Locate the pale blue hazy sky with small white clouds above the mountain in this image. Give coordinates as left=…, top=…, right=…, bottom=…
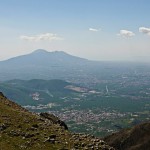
left=0, top=0, right=150, bottom=61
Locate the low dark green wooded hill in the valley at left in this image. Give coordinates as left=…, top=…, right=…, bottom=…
left=0, top=79, right=74, bottom=105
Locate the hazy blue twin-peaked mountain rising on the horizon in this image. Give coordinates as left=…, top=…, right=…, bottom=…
left=0, top=49, right=88, bottom=66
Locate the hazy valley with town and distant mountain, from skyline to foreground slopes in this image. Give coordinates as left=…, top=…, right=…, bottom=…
left=0, top=49, right=150, bottom=137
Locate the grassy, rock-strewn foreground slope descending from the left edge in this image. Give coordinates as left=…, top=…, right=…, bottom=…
left=0, top=92, right=113, bottom=150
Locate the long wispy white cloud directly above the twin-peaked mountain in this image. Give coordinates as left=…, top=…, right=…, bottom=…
left=20, top=33, right=63, bottom=42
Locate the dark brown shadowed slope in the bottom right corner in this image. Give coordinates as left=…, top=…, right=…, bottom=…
left=104, top=122, right=150, bottom=150
